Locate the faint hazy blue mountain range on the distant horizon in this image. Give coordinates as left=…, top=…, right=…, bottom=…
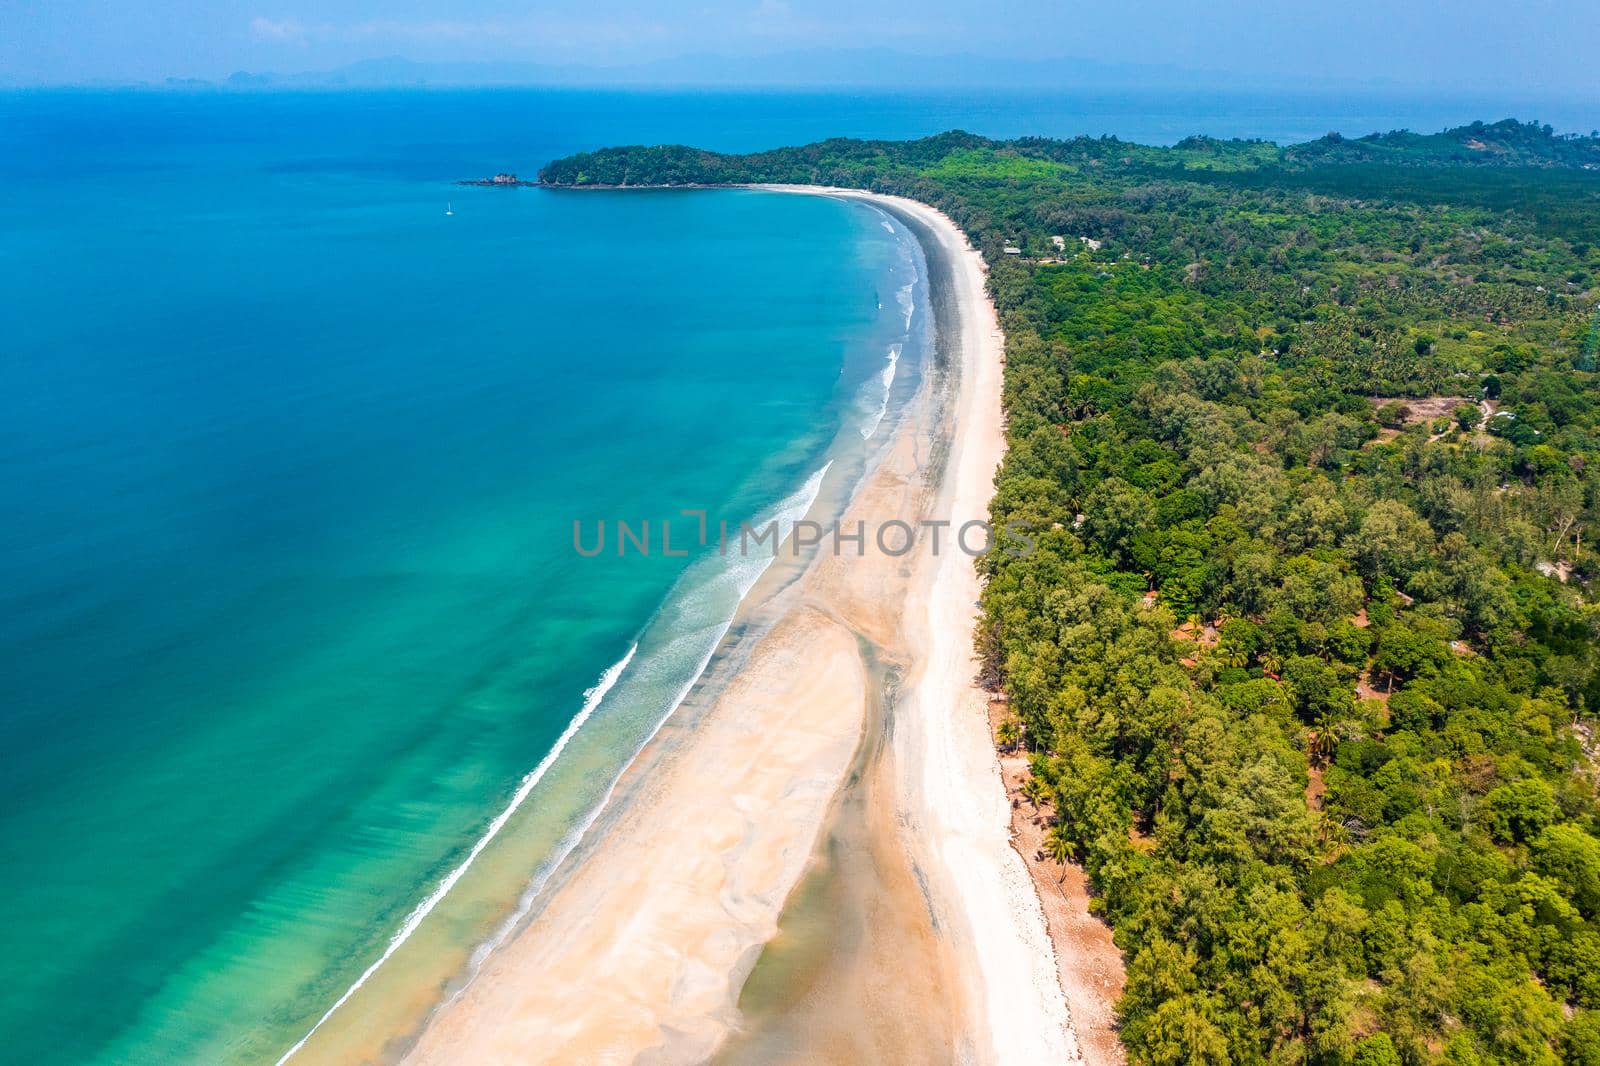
left=206, top=48, right=1324, bottom=90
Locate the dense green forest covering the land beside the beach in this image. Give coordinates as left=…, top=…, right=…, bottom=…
left=542, top=122, right=1600, bottom=1066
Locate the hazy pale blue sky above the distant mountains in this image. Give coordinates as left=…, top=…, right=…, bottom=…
left=0, top=0, right=1600, bottom=98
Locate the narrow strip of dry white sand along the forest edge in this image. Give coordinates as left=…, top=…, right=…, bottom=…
left=876, top=186, right=1082, bottom=1063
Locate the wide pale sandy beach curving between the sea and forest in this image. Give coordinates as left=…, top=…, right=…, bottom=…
left=392, top=189, right=1078, bottom=1063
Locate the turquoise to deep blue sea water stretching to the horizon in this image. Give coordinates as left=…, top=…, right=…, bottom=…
left=0, top=91, right=1578, bottom=1063
